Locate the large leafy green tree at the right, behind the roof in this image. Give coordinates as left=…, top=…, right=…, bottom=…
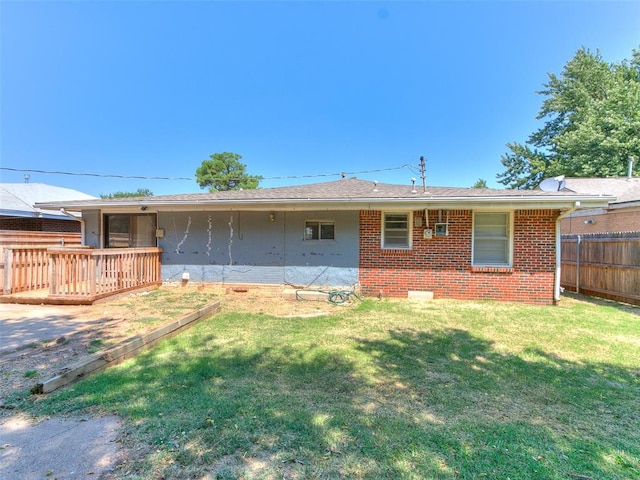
left=497, top=48, right=640, bottom=188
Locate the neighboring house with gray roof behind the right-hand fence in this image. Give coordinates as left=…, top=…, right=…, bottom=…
left=562, top=177, right=640, bottom=235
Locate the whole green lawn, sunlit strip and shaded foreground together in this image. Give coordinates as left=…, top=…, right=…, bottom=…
left=17, top=297, right=640, bottom=479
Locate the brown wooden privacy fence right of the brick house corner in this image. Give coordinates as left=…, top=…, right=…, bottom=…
left=560, top=232, right=640, bottom=305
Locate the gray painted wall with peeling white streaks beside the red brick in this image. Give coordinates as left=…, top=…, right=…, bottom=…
left=158, top=211, right=359, bottom=286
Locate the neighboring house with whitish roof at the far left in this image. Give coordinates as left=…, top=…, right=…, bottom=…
left=0, top=183, right=95, bottom=233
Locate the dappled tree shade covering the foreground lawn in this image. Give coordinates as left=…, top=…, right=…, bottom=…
left=27, top=320, right=640, bottom=479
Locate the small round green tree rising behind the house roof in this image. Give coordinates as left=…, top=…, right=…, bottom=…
left=196, top=152, right=262, bottom=192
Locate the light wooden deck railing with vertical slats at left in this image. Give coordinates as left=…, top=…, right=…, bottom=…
left=4, top=247, right=162, bottom=303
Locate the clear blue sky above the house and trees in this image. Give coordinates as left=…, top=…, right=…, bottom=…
left=0, top=0, right=640, bottom=196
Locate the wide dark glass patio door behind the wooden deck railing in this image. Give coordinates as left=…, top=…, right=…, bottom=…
left=104, top=214, right=157, bottom=248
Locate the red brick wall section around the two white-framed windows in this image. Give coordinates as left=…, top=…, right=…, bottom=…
left=359, top=210, right=560, bottom=304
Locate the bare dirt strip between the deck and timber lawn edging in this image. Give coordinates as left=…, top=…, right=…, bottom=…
left=0, top=285, right=336, bottom=404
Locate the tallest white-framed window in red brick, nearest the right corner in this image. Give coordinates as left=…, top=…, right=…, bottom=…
left=472, top=212, right=511, bottom=266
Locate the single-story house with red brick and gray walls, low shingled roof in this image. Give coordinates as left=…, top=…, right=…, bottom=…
left=33, top=179, right=614, bottom=304
